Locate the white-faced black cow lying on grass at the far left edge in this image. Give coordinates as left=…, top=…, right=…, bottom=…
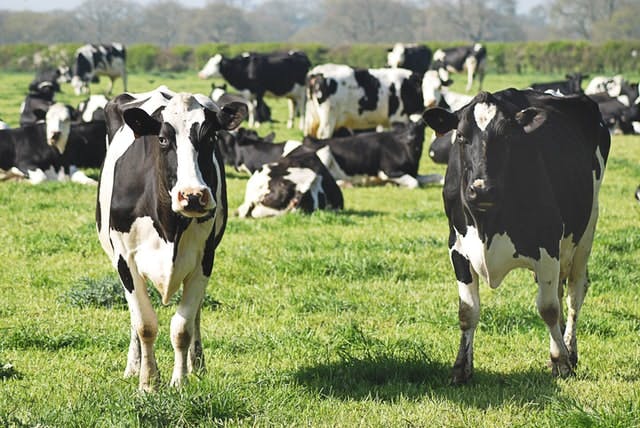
left=0, top=103, right=95, bottom=184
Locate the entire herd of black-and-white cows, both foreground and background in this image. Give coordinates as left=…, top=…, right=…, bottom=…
left=0, top=40, right=640, bottom=390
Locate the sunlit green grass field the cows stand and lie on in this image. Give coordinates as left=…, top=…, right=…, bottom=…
left=0, top=73, right=640, bottom=427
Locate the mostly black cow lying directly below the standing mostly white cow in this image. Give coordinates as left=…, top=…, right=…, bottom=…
left=303, top=113, right=442, bottom=189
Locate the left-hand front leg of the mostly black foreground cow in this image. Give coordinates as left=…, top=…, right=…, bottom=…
left=449, top=249, right=480, bottom=385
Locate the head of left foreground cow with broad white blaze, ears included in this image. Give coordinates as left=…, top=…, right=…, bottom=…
left=123, top=93, right=247, bottom=217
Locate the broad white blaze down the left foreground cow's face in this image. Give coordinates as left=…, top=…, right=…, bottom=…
left=162, top=93, right=216, bottom=216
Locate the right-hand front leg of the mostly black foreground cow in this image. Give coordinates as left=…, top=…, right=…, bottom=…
left=535, top=256, right=573, bottom=377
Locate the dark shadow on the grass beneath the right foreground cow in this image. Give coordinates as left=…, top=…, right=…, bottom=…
left=294, top=357, right=559, bottom=409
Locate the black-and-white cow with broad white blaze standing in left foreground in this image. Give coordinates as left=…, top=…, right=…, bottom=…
left=96, top=87, right=247, bottom=390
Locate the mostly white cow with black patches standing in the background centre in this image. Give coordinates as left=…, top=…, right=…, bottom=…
left=304, top=64, right=424, bottom=138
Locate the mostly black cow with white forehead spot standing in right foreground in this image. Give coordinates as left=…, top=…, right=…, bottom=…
left=424, top=89, right=610, bottom=384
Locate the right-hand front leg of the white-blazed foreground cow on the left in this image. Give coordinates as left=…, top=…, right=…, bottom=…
left=171, top=273, right=208, bottom=386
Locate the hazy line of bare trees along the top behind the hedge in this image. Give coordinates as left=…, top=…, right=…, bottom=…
left=0, top=0, right=640, bottom=48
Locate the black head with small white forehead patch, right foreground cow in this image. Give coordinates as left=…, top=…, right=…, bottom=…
left=424, top=92, right=547, bottom=212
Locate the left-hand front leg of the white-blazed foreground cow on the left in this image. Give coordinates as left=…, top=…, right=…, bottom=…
left=118, top=270, right=160, bottom=391
